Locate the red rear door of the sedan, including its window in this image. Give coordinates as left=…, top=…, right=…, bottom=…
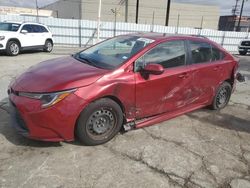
left=189, top=40, right=226, bottom=104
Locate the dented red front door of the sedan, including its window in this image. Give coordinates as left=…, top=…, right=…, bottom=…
left=135, top=40, right=192, bottom=119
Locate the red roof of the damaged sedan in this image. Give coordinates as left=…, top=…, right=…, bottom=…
left=125, top=32, right=207, bottom=41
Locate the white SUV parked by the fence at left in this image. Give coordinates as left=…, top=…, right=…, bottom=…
left=0, top=21, right=53, bottom=56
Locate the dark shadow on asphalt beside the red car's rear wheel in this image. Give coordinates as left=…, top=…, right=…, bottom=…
left=186, top=106, right=250, bottom=133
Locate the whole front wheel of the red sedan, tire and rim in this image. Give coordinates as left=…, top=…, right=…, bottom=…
left=76, top=98, right=123, bottom=146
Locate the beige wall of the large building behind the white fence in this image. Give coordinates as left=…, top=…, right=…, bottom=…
left=45, top=0, right=219, bottom=29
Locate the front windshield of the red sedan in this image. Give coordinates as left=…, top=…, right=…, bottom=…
left=75, top=36, right=154, bottom=69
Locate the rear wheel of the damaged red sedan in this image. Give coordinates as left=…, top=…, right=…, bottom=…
left=211, top=82, right=232, bottom=110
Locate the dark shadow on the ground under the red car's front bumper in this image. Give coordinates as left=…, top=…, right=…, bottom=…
left=0, top=98, right=61, bottom=148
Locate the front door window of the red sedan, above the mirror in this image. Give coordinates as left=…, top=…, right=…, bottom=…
left=135, top=40, right=186, bottom=71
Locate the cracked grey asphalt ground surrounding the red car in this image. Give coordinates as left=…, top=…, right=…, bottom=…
left=0, top=48, right=250, bottom=188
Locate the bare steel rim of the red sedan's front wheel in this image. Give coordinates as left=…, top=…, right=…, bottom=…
left=86, top=108, right=117, bottom=140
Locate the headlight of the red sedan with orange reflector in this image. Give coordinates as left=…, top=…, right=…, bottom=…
left=19, top=89, right=76, bottom=108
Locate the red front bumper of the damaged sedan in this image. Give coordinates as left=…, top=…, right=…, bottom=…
left=9, top=93, right=87, bottom=142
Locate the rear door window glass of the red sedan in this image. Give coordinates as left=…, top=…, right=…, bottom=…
left=189, top=41, right=212, bottom=64
